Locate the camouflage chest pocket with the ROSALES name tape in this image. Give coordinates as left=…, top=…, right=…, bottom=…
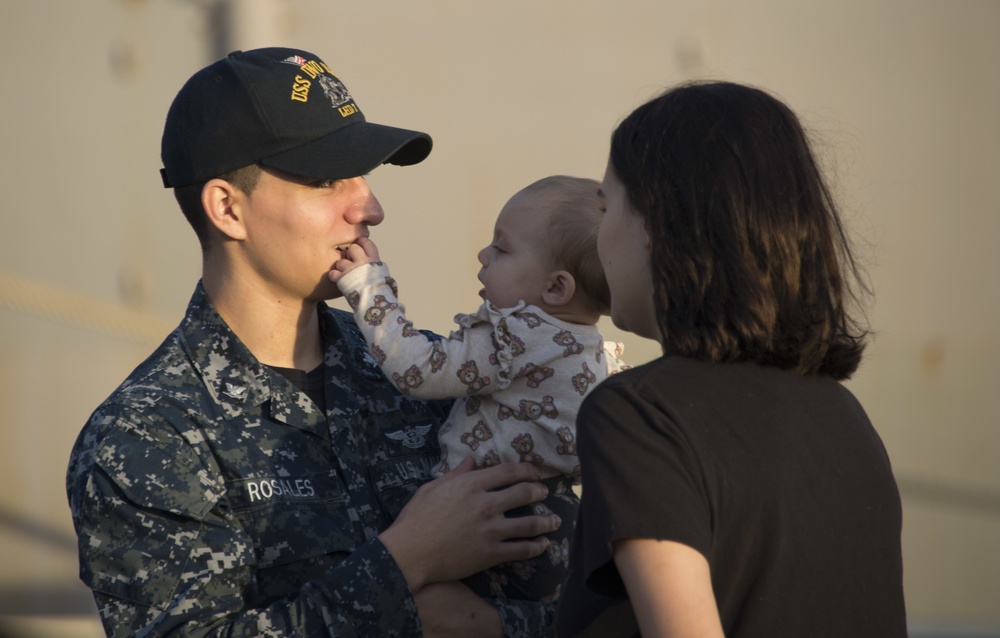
left=228, top=474, right=358, bottom=569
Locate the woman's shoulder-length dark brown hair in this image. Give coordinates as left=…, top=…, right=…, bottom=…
left=610, top=82, right=868, bottom=379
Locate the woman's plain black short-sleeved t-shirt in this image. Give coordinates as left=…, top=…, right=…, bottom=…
left=557, top=357, right=906, bottom=638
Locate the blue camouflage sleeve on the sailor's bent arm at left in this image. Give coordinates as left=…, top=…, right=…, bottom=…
left=67, top=411, right=421, bottom=637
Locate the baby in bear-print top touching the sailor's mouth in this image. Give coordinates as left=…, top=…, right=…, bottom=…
left=330, top=176, right=626, bottom=602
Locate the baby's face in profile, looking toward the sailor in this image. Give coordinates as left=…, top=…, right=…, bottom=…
left=479, top=193, right=553, bottom=308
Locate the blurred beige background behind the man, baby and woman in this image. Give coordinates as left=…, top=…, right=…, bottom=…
left=0, top=0, right=1000, bottom=637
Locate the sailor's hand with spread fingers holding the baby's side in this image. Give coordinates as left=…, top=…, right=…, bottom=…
left=379, top=457, right=561, bottom=592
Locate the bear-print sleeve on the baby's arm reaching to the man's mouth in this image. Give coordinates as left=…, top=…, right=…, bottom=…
left=338, top=262, right=511, bottom=399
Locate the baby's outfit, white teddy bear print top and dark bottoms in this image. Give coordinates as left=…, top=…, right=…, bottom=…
left=339, top=262, right=627, bottom=602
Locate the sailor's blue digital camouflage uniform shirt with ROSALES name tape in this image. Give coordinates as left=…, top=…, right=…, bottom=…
left=67, top=284, right=552, bottom=637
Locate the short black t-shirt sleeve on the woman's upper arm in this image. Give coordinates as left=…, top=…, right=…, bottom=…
left=577, top=375, right=712, bottom=597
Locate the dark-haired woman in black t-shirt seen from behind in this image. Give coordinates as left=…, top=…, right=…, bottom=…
left=557, top=83, right=906, bottom=638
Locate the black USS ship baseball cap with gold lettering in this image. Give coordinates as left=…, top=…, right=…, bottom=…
left=160, top=47, right=431, bottom=188
